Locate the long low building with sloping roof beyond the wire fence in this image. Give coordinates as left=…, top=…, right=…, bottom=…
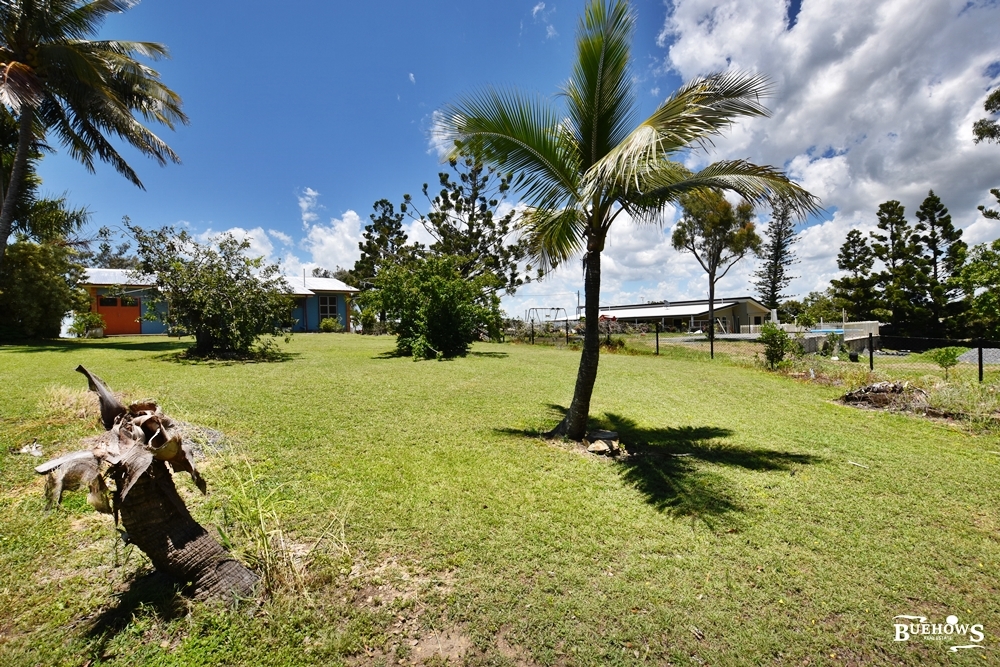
left=600, top=296, right=771, bottom=333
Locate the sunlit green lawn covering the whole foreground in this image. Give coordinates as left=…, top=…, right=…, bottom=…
left=0, top=335, right=1000, bottom=665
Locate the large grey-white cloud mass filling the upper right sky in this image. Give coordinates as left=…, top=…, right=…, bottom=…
left=659, top=0, right=1000, bottom=294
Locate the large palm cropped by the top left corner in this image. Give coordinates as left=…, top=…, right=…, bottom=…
left=0, top=0, right=187, bottom=272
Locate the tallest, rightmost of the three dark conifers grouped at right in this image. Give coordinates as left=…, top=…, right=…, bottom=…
left=916, top=190, right=968, bottom=336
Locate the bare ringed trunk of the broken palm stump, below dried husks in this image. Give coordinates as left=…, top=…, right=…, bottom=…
left=119, top=460, right=257, bottom=600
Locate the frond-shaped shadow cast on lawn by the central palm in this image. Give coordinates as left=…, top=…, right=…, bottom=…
left=598, top=413, right=822, bottom=529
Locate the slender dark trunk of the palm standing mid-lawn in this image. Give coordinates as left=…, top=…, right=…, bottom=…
left=551, top=250, right=601, bottom=440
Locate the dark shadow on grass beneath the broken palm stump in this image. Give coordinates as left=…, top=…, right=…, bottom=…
left=87, top=572, right=187, bottom=648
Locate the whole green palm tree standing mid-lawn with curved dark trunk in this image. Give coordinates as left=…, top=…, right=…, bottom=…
left=442, top=0, right=818, bottom=440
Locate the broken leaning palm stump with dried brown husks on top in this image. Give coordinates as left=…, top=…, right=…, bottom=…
left=35, top=366, right=257, bottom=599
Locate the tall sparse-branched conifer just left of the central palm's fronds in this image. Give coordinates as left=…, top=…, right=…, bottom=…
left=400, top=156, right=531, bottom=294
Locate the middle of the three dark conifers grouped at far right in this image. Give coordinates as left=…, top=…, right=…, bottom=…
left=871, top=200, right=931, bottom=336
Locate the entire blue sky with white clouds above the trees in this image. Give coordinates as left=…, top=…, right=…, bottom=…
left=40, top=0, right=1000, bottom=314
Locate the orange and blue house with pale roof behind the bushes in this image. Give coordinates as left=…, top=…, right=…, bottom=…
left=81, top=269, right=358, bottom=336
